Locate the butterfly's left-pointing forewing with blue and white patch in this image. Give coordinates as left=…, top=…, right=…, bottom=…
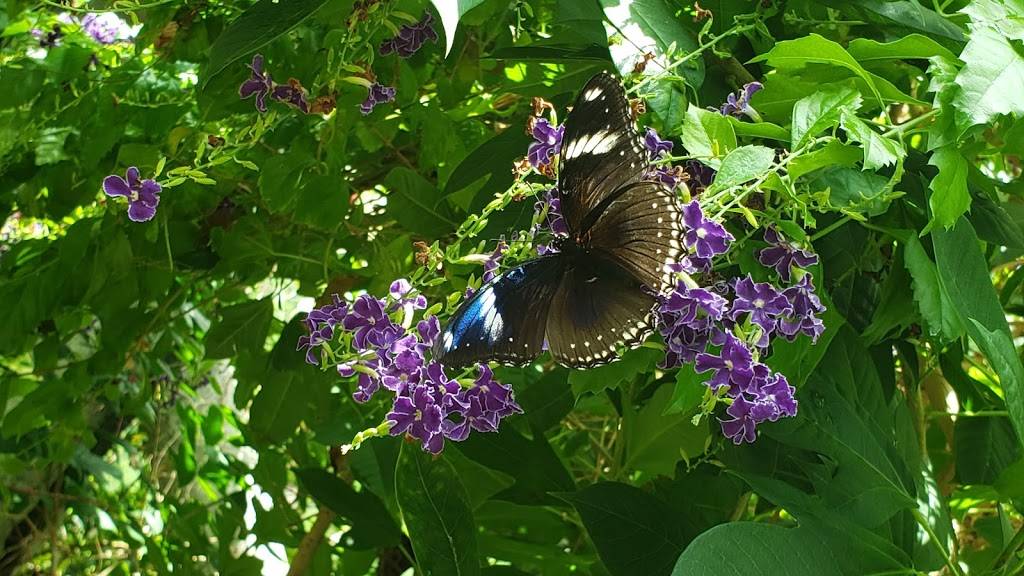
left=433, top=254, right=563, bottom=367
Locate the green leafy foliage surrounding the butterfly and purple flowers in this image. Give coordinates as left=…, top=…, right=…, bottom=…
left=0, top=0, right=1024, bottom=576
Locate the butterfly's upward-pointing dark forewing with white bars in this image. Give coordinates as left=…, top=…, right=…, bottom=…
left=558, top=72, right=647, bottom=232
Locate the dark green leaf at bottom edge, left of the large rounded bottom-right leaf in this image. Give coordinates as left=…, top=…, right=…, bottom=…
left=558, top=482, right=689, bottom=576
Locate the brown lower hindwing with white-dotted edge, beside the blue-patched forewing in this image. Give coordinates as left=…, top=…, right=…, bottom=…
left=547, top=253, right=655, bottom=368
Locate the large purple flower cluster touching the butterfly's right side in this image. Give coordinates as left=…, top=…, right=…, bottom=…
left=657, top=201, right=824, bottom=444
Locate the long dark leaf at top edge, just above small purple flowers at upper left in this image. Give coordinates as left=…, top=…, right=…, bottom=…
left=201, top=0, right=327, bottom=89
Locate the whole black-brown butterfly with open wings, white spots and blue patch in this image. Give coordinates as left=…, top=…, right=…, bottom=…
left=434, top=73, right=682, bottom=368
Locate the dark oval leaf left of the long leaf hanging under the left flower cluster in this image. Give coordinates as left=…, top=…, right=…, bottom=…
left=295, top=468, right=401, bottom=549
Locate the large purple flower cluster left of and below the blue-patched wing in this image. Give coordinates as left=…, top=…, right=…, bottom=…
left=298, top=280, right=522, bottom=453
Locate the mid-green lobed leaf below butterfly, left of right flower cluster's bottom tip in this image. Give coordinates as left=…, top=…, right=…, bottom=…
left=623, top=384, right=711, bottom=477
